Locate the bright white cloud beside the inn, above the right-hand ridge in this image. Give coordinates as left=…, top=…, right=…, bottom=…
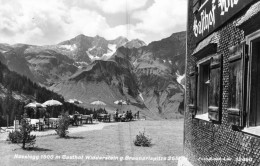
left=132, top=0, right=187, bottom=40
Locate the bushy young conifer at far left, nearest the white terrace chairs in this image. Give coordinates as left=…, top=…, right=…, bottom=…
left=9, top=118, right=36, bottom=149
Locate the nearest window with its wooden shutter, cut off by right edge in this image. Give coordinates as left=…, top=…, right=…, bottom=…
left=227, top=30, right=260, bottom=135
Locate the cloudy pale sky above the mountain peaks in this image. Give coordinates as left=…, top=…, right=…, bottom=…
left=0, top=0, right=187, bottom=45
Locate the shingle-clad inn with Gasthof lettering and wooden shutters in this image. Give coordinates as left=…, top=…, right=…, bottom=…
left=184, top=0, right=260, bottom=166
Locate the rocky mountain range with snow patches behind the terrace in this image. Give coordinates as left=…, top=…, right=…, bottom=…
left=0, top=32, right=186, bottom=119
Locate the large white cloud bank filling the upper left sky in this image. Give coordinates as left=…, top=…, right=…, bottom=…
left=0, top=0, right=109, bottom=45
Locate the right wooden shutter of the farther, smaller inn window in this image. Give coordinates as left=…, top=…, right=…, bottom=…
left=208, top=55, right=223, bottom=122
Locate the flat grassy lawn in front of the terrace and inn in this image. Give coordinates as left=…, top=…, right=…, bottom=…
left=0, top=119, right=183, bottom=166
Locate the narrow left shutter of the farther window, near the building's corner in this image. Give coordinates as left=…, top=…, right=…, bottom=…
left=189, top=67, right=198, bottom=116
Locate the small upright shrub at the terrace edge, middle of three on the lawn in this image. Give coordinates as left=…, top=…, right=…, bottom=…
left=55, top=112, right=70, bottom=138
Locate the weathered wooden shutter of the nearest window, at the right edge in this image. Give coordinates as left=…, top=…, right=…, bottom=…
left=227, top=43, right=247, bottom=130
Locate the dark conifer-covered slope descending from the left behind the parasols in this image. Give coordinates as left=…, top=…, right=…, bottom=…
left=0, top=62, right=92, bottom=126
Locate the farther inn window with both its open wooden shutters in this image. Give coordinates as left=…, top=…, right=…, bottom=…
left=190, top=54, right=222, bottom=122
